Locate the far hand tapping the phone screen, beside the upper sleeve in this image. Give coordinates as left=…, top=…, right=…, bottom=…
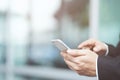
left=78, top=39, right=107, bottom=55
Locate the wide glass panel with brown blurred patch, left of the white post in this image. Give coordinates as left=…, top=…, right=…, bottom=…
left=28, top=0, right=89, bottom=68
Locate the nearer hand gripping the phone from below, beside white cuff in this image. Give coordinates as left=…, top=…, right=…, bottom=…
left=61, top=50, right=98, bottom=76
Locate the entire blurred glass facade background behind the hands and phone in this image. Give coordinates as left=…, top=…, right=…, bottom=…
left=0, top=0, right=120, bottom=80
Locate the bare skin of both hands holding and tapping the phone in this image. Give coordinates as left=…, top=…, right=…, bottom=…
left=61, top=39, right=106, bottom=76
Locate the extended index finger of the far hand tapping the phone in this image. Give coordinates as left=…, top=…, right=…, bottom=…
left=78, top=39, right=95, bottom=49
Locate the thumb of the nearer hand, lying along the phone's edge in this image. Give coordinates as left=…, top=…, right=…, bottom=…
left=67, top=49, right=86, bottom=57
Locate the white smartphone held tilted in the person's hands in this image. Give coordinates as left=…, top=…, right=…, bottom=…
left=52, top=39, right=70, bottom=52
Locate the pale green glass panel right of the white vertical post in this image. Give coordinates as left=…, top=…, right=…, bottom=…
left=99, top=0, right=120, bottom=45
